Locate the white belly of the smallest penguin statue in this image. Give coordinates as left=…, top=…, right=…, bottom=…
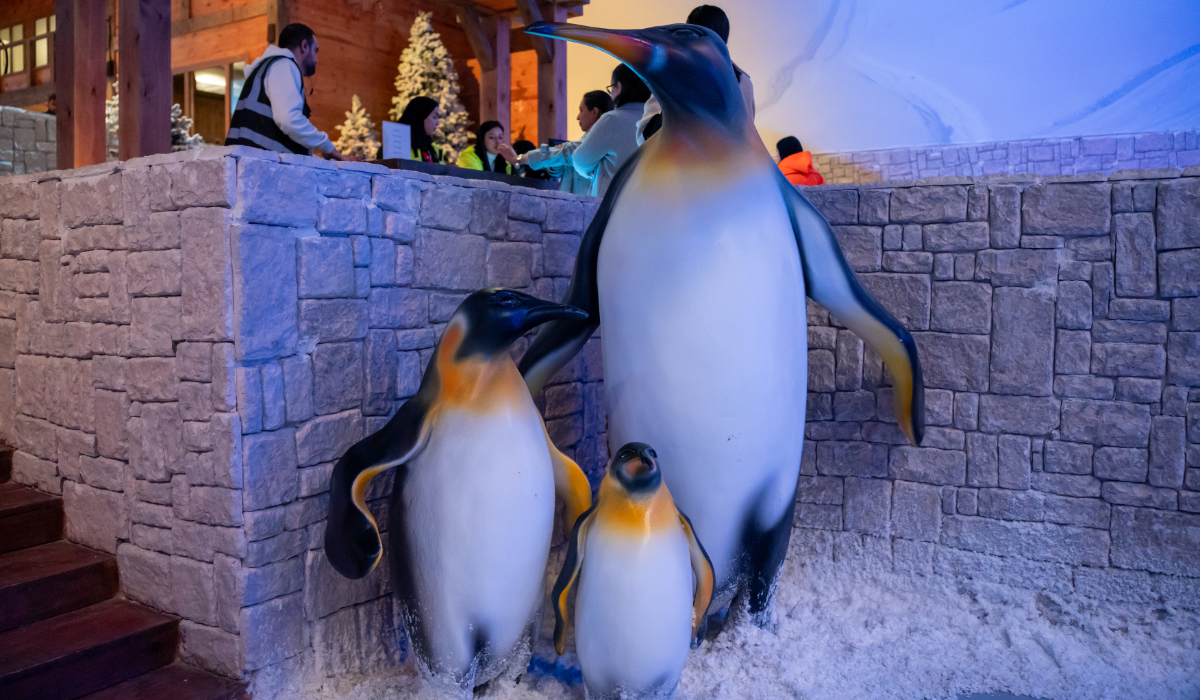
left=575, top=527, right=692, bottom=698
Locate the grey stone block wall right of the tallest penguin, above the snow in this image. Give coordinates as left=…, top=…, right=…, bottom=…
left=797, top=168, right=1200, bottom=608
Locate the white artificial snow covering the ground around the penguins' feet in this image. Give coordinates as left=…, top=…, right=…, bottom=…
left=258, top=539, right=1200, bottom=700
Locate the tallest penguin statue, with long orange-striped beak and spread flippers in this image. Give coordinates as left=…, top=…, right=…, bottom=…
left=521, top=23, right=924, bottom=626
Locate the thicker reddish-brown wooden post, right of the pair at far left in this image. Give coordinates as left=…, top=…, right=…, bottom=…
left=118, top=0, right=172, bottom=161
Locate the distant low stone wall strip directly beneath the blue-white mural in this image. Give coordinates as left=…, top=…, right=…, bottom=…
left=814, top=131, right=1200, bottom=184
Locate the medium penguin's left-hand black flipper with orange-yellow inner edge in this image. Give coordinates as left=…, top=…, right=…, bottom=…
left=325, top=394, right=430, bottom=579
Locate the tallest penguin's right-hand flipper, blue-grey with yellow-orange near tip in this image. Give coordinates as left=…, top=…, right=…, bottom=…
left=775, top=168, right=925, bottom=445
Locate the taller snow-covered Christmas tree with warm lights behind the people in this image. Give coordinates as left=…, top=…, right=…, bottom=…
left=389, top=12, right=473, bottom=163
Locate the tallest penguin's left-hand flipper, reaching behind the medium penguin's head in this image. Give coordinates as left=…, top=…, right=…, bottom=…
left=520, top=150, right=642, bottom=396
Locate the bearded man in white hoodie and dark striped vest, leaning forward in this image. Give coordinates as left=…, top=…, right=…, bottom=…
left=226, top=24, right=359, bottom=161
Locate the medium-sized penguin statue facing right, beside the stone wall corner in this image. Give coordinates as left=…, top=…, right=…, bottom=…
left=325, top=288, right=592, bottom=694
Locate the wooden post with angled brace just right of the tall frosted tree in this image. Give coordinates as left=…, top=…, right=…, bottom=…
left=457, top=5, right=512, bottom=133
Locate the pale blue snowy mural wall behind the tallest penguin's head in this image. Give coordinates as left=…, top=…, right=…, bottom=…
left=568, top=0, right=1200, bottom=151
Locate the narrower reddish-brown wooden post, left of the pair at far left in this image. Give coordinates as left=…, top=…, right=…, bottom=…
left=73, top=0, right=108, bottom=168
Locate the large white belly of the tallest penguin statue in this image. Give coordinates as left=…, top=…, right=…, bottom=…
left=598, top=163, right=808, bottom=593
